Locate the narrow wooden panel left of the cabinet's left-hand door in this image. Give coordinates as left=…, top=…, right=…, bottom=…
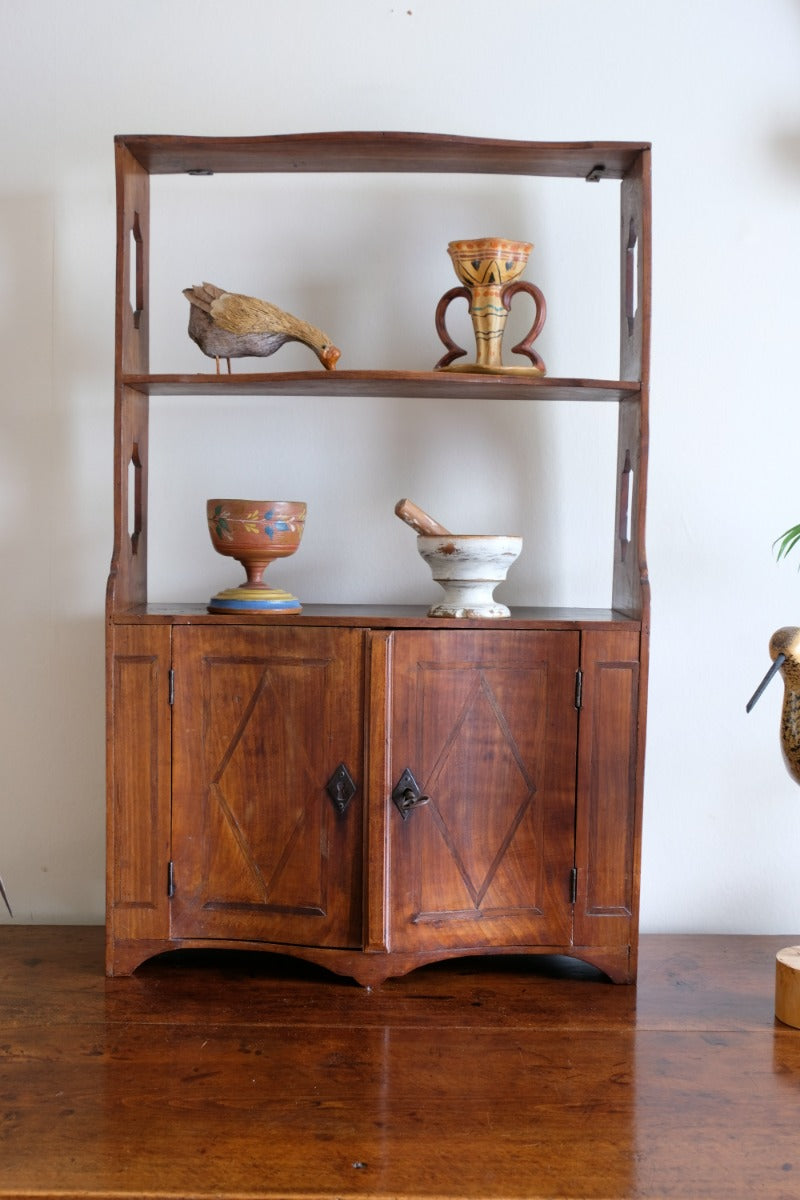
left=107, top=626, right=170, bottom=973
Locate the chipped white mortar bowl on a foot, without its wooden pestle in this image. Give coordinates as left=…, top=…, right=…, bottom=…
left=416, top=533, right=522, bottom=617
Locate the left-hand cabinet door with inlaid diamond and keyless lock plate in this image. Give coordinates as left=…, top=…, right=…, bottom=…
left=172, top=625, right=363, bottom=947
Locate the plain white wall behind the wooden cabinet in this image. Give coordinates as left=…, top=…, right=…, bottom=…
left=0, top=0, right=800, bottom=932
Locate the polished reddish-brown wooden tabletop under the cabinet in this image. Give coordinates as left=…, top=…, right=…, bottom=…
left=0, top=925, right=800, bottom=1200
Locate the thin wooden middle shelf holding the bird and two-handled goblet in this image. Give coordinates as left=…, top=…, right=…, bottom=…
left=121, top=371, right=642, bottom=402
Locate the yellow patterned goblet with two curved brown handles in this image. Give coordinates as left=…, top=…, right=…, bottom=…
left=435, top=238, right=547, bottom=376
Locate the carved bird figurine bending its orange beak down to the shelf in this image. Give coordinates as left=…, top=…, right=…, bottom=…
left=184, top=283, right=341, bottom=374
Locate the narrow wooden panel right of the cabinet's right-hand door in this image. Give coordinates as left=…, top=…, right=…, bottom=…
left=575, top=632, right=640, bottom=946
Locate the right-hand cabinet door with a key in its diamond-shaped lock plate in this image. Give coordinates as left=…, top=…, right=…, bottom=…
left=387, top=630, right=578, bottom=952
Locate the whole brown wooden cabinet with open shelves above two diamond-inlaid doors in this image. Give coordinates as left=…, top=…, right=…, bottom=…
left=107, top=133, right=650, bottom=984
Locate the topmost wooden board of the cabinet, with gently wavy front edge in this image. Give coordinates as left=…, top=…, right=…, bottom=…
left=114, top=132, right=650, bottom=180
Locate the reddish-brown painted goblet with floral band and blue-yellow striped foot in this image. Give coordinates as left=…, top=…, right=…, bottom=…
left=206, top=499, right=306, bottom=613
